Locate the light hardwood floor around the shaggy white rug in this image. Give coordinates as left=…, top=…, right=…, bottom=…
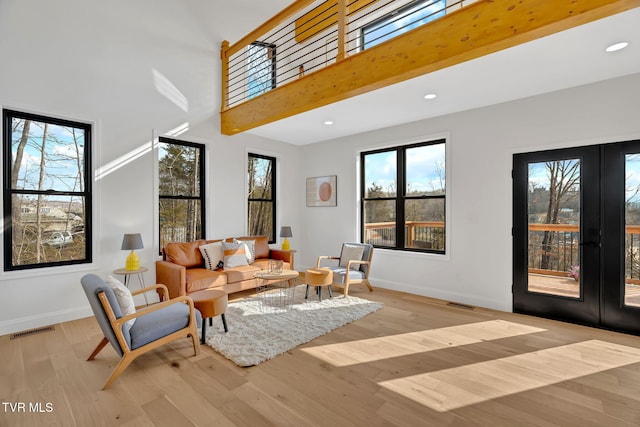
left=0, top=287, right=640, bottom=427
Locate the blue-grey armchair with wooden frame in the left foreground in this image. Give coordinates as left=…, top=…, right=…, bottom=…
left=80, top=274, right=202, bottom=390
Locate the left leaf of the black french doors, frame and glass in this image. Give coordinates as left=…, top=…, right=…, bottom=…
left=513, top=146, right=601, bottom=325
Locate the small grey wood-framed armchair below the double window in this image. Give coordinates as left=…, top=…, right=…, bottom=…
left=316, top=243, right=373, bottom=296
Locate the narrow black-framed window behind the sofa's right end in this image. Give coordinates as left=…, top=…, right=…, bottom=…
left=247, top=153, right=276, bottom=243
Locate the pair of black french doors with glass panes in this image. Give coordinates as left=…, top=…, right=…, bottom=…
left=513, top=141, right=640, bottom=333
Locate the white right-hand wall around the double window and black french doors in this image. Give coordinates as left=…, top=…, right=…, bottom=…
left=299, top=74, right=640, bottom=311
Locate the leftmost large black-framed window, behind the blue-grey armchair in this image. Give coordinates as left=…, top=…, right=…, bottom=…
left=3, top=110, right=91, bottom=271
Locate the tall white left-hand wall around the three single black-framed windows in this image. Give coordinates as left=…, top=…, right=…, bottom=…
left=0, top=0, right=302, bottom=335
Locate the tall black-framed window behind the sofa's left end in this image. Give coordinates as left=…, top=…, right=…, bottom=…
left=158, top=138, right=205, bottom=248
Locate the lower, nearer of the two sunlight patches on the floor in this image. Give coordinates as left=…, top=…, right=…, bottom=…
left=380, top=340, right=640, bottom=412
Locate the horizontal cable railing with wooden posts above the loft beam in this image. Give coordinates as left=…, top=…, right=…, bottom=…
left=221, top=0, right=475, bottom=111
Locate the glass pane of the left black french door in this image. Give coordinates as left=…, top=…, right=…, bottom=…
left=527, top=158, right=582, bottom=298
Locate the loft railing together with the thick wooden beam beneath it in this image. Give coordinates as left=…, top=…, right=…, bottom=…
left=220, top=0, right=640, bottom=135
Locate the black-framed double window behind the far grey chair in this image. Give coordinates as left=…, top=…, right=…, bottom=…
left=360, top=140, right=446, bottom=253
